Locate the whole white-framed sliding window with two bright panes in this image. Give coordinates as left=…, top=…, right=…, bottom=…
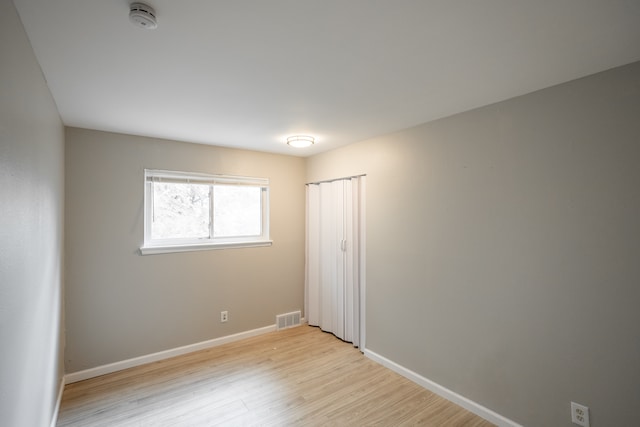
left=140, top=169, right=271, bottom=255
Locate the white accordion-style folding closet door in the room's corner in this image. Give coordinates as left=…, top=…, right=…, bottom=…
left=305, top=178, right=363, bottom=346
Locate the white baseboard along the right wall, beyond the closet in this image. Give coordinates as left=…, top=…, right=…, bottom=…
left=364, top=348, right=522, bottom=427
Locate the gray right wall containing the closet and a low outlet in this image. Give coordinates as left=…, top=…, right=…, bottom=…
left=307, top=63, right=640, bottom=427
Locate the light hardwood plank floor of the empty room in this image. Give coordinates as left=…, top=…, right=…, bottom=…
left=58, top=326, right=493, bottom=427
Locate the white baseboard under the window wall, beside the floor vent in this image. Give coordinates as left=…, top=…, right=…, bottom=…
left=64, top=319, right=280, bottom=384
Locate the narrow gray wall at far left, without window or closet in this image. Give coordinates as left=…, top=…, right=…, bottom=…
left=0, top=0, right=64, bottom=427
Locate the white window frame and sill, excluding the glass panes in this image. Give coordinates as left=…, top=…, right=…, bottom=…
left=140, top=169, right=273, bottom=255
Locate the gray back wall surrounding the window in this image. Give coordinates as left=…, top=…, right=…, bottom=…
left=65, top=128, right=305, bottom=372
